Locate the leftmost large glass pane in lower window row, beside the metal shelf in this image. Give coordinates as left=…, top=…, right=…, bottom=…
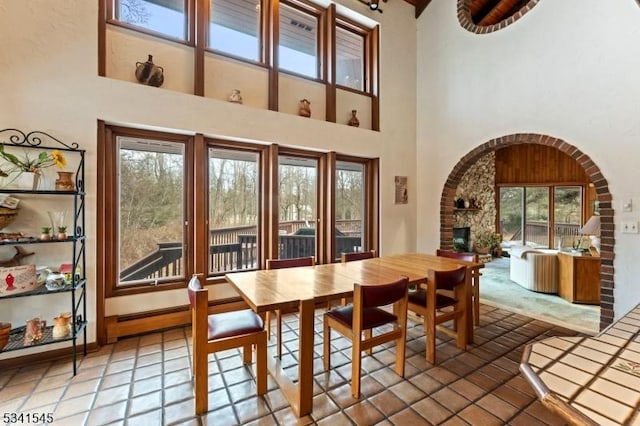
left=118, top=137, right=185, bottom=286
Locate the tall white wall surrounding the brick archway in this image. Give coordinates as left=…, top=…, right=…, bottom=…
left=417, top=0, right=640, bottom=318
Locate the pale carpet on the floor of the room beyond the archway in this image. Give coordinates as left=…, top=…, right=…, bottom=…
left=480, top=258, right=600, bottom=334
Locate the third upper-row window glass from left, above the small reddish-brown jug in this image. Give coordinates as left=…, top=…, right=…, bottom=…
left=278, top=3, right=318, bottom=78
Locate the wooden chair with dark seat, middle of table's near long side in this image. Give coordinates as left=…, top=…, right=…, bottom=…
left=323, top=277, right=409, bottom=398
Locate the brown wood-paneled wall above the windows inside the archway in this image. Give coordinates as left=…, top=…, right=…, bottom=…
left=496, top=144, right=589, bottom=185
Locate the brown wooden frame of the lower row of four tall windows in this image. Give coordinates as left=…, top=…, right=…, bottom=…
left=97, top=121, right=380, bottom=296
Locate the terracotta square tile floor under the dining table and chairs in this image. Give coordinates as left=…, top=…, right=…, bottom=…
left=0, top=305, right=577, bottom=426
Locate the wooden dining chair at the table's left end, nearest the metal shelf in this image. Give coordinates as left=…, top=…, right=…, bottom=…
left=187, top=276, right=267, bottom=415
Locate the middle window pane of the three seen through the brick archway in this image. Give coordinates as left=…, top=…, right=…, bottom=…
left=524, top=187, right=549, bottom=248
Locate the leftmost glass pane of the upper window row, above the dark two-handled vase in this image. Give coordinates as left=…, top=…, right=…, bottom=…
left=115, top=0, right=187, bottom=40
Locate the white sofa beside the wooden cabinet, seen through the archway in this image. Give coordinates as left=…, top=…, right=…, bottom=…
left=509, top=247, right=558, bottom=293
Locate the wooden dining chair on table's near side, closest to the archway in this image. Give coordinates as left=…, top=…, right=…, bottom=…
left=407, top=266, right=471, bottom=364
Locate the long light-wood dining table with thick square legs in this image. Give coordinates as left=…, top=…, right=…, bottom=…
left=226, top=253, right=482, bottom=417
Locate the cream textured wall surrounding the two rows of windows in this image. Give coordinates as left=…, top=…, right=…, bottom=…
left=0, top=0, right=417, bottom=352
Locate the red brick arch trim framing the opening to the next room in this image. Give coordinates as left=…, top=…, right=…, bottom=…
left=440, top=133, right=615, bottom=330
